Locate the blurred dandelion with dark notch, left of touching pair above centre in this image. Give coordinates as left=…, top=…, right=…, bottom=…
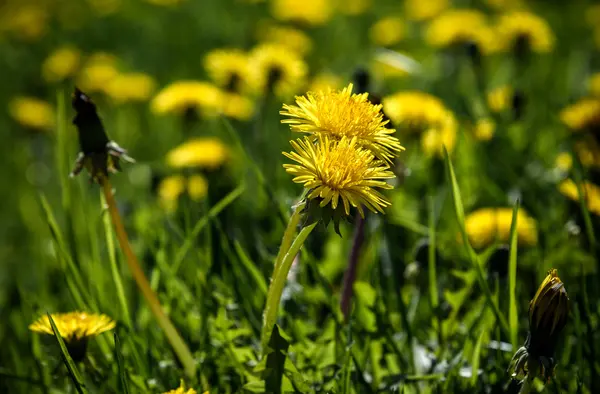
left=204, top=49, right=248, bottom=92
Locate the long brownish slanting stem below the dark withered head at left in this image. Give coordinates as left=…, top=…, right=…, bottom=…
left=101, top=177, right=196, bottom=377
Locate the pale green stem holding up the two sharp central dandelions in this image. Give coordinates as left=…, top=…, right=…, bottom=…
left=261, top=220, right=318, bottom=356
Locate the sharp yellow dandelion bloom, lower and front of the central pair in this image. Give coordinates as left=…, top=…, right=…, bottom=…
left=283, top=136, right=394, bottom=217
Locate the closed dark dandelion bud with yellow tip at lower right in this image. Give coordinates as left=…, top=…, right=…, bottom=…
left=509, top=269, right=569, bottom=384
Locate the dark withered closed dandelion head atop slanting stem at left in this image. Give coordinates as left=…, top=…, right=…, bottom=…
left=71, top=88, right=135, bottom=183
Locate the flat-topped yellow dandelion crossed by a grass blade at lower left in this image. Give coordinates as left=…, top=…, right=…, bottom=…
left=29, top=312, right=116, bottom=361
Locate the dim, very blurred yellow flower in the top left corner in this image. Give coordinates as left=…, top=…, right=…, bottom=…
left=0, top=1, right=50, bottom=41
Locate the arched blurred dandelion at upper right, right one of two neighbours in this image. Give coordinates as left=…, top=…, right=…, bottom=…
left=496, top=11, right=554, bottom=53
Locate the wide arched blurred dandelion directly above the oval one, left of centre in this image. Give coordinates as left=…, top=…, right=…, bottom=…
left=151, top=81, right=222, bottom=114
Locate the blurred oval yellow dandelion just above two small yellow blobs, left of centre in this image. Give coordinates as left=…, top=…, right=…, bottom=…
left=166, top=137, right=229, bottom=169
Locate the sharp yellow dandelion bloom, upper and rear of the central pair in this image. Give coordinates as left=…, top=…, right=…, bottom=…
left=280, top=84, right=404, bottom=161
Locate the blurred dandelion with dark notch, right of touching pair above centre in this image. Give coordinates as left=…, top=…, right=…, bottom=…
left=249, top=43, right=308, bottom=97
